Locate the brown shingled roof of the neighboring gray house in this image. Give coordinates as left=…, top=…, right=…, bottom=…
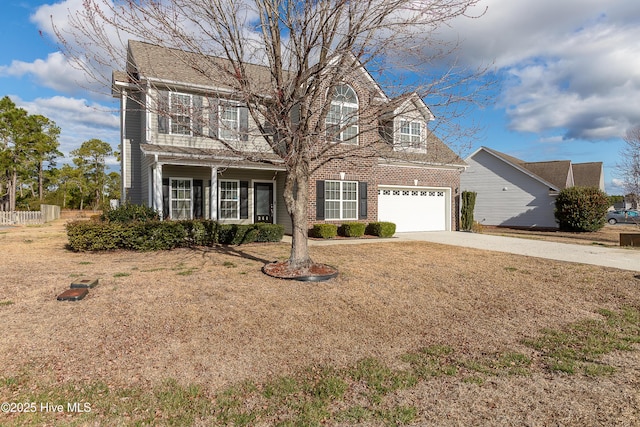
left=469, top=147, right=604, bottom=190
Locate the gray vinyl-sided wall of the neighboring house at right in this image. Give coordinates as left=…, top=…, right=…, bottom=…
left=461, top=150, right=557, bottom=231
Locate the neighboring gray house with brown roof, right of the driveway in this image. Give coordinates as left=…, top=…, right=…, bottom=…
left=460, top=147, right=604, bottom=228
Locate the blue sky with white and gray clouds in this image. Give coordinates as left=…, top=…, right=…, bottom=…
left=0, top=0, right=640, bottom=194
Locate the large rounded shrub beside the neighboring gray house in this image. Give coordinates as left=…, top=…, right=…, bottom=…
left=555, top=187, right=609, bottom=231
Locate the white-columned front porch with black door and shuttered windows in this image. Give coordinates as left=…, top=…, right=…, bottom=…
left=140, top=147, right=291, bottom=229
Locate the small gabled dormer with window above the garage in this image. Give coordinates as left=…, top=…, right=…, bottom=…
left=380, top=92, right=435, bottom=153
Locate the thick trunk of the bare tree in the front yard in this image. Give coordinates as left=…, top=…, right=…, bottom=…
left=284, top=162, right=313, bottom=269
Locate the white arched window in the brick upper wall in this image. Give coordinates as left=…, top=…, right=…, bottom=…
left=326, top=84, right=358, bottom=144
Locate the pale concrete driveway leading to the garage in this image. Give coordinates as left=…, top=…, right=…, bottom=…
left=309, top=231, right=640, bottom=271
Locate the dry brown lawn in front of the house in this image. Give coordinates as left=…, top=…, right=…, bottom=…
left=0, top=212, right=640, bottom=426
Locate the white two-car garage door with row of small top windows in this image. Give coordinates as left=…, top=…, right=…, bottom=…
left=378, top=187, right=449, bottom=232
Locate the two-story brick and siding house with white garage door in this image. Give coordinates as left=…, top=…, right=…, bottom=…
left=113, top=41, right=465, bottom=232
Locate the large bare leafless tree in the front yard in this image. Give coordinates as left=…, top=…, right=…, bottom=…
left=57, top=0, right=482, bottom=269
